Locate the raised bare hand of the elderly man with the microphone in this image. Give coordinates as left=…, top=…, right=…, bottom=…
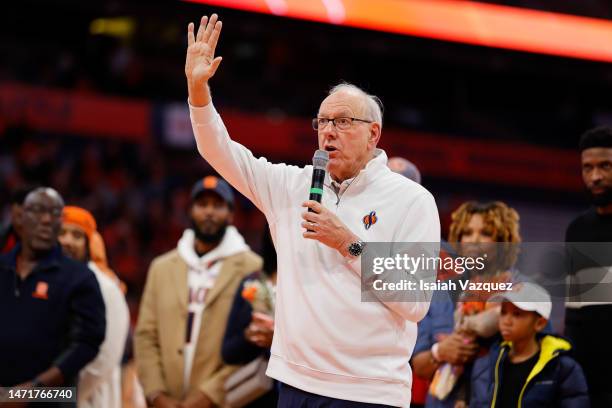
left=185, top=14, right=222, bottom=106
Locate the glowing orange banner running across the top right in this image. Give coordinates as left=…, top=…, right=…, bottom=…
left=185, top=0, right=612, bottom=62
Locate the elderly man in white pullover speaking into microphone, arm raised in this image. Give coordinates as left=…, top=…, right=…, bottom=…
left=185, top=14, right=440, bottom=407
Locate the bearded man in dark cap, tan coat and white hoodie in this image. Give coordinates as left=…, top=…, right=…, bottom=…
left=134, top=176, right=262, bottom=407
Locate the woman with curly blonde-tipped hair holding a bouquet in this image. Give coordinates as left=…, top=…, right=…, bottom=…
left=412, top=201, right=521, bottom=408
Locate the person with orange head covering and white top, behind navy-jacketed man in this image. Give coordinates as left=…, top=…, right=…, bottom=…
left=59, top=206, right=129, bottom=408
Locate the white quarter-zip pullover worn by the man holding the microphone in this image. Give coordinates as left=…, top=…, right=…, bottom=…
left=190, top=103, right=440, bottom=407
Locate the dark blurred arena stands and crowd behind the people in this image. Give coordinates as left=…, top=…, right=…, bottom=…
left=0, top=0, right=612, bottom=312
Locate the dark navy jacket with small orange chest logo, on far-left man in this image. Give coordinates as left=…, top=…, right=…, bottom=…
left=0, top=245, right=106, bottom=386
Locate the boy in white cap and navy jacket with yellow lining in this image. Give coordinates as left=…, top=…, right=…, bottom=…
left=469, top=283, right=590, bottom=408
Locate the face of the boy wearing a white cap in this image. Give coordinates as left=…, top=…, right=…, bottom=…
left=499, top=302, right=546, bottom=342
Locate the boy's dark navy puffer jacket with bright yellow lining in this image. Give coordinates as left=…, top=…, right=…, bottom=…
left=469, top=335, right=590, bottom=408
